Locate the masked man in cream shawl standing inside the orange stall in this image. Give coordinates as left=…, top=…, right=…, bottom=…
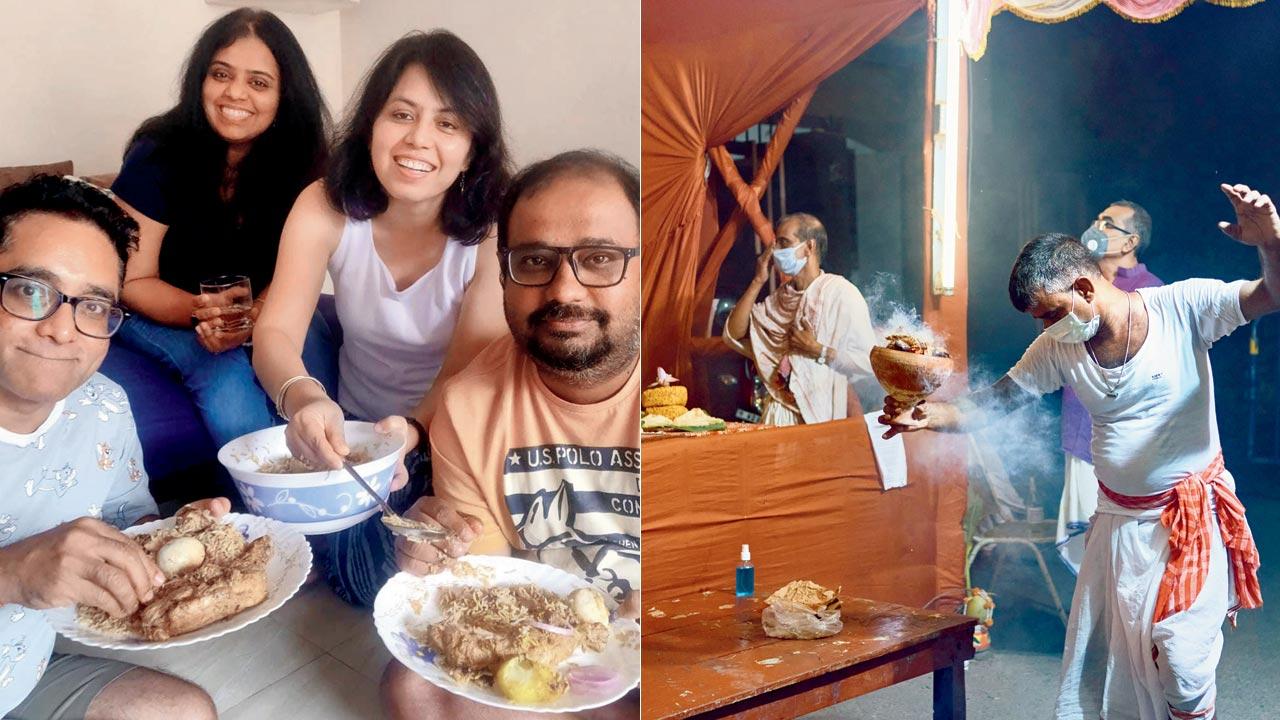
left=723, top=213, right=879, bottom=425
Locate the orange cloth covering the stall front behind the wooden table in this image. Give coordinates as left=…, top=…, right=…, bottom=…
left=641, top=416, right=966, bottom=604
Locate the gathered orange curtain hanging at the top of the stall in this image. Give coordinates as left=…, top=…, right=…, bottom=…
left=641, top=0, right=922, bottom=377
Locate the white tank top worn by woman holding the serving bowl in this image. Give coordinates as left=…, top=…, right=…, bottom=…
left=329, top=218, right=476, bottom=421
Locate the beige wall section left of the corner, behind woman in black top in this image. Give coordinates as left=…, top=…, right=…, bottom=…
left=0, top=0, right=344, bottom=174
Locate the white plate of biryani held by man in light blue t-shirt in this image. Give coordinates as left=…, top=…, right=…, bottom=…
left=45, top=509, right=311, bottom=650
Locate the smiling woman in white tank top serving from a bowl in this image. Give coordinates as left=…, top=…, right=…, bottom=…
left=253, top=31, right=509, bottom=603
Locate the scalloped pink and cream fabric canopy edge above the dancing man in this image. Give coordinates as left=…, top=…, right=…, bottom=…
left=956, top=0, right=1262, bottom=60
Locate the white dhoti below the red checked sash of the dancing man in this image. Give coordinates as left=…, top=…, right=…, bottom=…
left=1053, top=489, right=1234, bottom=720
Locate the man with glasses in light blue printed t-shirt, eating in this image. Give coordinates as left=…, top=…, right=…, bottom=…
left=0, top=176, right=216, bottom=720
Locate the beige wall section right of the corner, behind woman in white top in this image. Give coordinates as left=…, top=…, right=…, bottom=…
left=342, top=0, right=640, bottom=167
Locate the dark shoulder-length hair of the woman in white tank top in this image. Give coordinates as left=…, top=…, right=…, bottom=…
left=325, top=29, right=511, bottom=245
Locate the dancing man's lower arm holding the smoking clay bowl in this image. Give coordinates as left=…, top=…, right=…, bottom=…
left=879, top=375, right=1037, bottom=439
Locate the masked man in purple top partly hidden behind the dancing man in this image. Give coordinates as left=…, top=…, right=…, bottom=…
left=1057, top=200, right=1165, bottom=573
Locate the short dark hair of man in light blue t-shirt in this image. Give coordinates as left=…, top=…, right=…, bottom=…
left=0, top=176, right=138, bottom=274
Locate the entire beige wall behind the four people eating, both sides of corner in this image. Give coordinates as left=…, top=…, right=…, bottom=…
left=0, top=0, right=640, bottom=174
